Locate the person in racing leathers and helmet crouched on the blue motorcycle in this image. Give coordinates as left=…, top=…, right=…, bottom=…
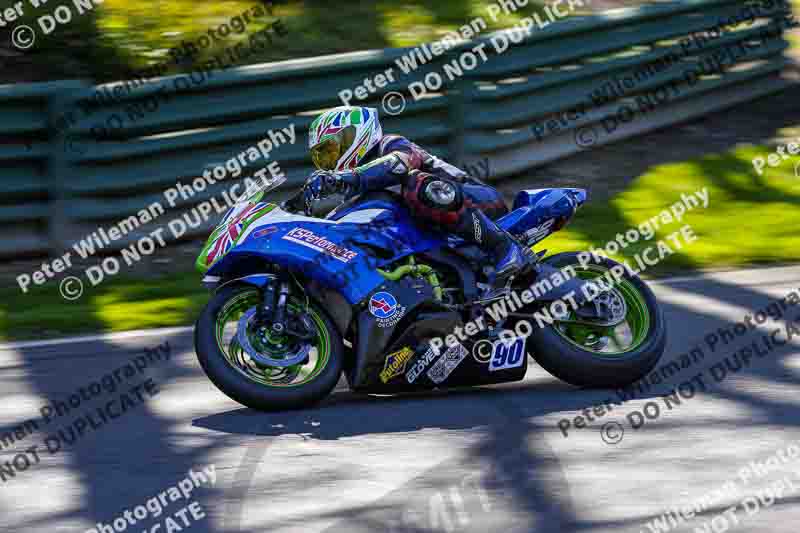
left=306, top=106, right=534, bottom=287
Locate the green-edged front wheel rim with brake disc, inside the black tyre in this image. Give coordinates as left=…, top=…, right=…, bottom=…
left=215, top=290, right=331, bottom=388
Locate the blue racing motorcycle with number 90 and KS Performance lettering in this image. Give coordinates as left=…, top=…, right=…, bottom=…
left=194, top=177, right=666, bottom=411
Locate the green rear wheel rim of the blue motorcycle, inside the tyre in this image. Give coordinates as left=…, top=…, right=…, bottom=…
left=553, top=265, right=650, bottom=357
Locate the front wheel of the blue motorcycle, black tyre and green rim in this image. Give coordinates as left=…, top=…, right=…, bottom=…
left=194, top=286, right=343, bottom=411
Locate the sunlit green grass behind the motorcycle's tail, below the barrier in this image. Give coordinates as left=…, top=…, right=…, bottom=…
left=543, top=143, right=800, bottom=275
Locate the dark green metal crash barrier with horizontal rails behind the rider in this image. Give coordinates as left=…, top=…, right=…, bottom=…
left=0, top=0, right=790, bottom=257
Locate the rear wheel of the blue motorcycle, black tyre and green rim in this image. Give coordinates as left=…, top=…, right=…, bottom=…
left=531, top=252, right=667, bottom=388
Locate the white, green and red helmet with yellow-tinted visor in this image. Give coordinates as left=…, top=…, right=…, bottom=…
left=308, top=106, right=383, bottom=171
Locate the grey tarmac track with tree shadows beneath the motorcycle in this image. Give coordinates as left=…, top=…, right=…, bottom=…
left=0, top=267, right=800, bottom=533
